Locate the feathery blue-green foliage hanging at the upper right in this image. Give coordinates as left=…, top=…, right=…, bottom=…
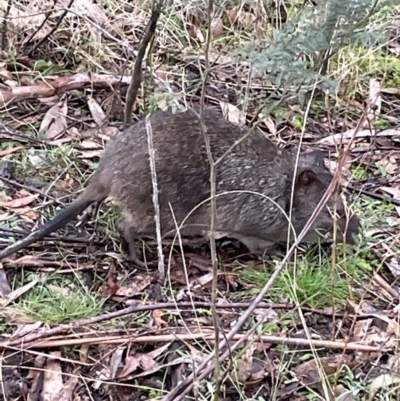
left=238, top=0, right=393, bottom=92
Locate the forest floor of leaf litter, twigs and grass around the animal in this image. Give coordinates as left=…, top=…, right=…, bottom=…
left=0, top=0, right=400, bottom=401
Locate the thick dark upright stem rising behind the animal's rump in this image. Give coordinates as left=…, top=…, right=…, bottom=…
left=122, top=0, right=162, bottom=128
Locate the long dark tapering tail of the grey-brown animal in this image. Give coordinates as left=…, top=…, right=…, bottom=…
left=0, top=198, right=94, bottom=260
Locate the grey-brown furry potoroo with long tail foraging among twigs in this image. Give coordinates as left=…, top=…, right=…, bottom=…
left=0, top=108, right=359, bottom=263
